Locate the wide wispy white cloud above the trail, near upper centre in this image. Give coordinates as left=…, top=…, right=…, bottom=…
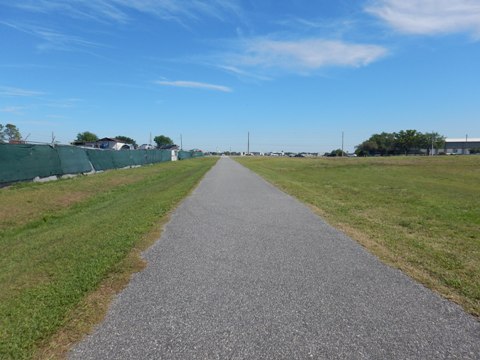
left=224, top=38, right=388, bottom=73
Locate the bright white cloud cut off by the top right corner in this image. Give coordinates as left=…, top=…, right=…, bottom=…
left=366, top=0, right=480, bottom=39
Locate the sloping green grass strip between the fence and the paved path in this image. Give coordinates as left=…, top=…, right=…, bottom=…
left=0, top=158, right=216, bottom=359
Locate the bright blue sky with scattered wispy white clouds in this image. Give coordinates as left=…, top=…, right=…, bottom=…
left=0, top=0, right=480, bottom=152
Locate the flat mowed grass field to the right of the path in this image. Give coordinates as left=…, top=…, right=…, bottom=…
left=236, top=156, right=480, bottom=316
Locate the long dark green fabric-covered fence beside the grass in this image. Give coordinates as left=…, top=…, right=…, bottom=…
left=0, top=144, right=199, bottom=184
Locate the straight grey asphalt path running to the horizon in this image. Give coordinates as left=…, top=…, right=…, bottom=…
left=70, top=158, right=480, bottom=359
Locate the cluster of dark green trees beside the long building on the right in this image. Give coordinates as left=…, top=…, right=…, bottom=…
left=355, top=130, right=445, bottom=156
